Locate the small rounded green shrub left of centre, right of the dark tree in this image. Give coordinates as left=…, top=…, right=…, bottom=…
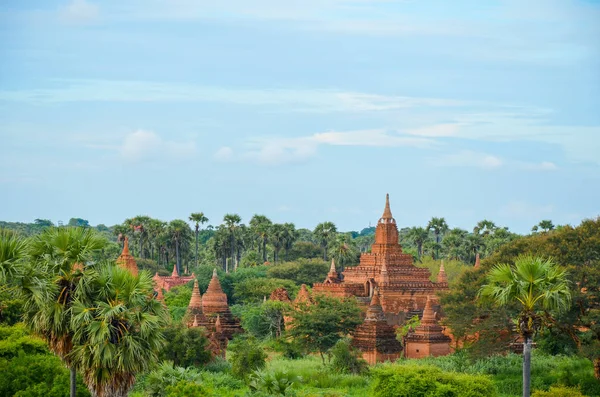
left=229, top=336, right=267, bottom=378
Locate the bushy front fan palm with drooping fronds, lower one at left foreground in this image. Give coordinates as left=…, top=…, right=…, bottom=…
left=70, top=263, right=169, bottom=397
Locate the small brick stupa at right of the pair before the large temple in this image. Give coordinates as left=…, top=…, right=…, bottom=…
left=404, top=297, right=450, bottom=358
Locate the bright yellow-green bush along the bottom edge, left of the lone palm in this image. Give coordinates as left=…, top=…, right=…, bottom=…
left=371, top=364, right=497, bottom=397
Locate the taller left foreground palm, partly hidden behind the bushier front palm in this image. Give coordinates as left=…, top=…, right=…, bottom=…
left=23, top=227, right=106, bottom=397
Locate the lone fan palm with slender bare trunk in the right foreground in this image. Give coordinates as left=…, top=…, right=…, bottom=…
left=480, top=256, right=571, bottom=397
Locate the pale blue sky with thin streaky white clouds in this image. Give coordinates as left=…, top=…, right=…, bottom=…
left=0, top=0, right=600, bottom=233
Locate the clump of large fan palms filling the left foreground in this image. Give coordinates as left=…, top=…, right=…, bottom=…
left=0, top=227, right=169, bottom=397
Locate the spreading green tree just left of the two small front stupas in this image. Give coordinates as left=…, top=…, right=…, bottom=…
left=289, top=295, right=362, bottom=363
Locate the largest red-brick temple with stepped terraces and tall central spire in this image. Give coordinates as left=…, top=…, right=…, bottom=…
left=313, top=195, right=448, bottom=325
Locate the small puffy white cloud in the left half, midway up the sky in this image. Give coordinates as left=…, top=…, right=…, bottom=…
left=119, top=130, right=196, bottom=162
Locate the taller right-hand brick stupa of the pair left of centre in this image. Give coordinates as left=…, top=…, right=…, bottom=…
left=202, top=269, right=241, bottom=339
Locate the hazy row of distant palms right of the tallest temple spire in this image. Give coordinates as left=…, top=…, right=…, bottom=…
left=401, top=218, right=517, bottom=263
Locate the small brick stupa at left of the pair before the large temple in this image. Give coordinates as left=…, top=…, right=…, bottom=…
left=352, top=290, right=402, bottom=365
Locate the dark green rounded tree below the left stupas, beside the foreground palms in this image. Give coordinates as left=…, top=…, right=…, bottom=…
left=159, top=323, right=212, bottom=367
